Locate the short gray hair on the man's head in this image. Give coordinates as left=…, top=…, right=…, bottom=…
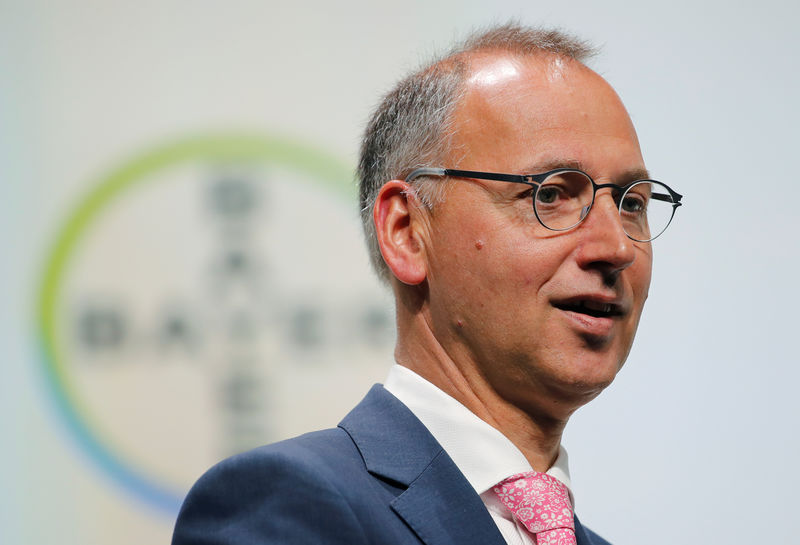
left=358, top=23, right=594, bottom=282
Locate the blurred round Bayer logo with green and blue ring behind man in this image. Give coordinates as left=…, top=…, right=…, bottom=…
left=40, top=136, right=394, bottom=510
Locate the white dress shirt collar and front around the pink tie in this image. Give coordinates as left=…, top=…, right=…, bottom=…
left=384, top=364, right=575, bottom=545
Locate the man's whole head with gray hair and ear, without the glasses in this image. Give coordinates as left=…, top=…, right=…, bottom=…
left=360, top=23, right=652, bottom=415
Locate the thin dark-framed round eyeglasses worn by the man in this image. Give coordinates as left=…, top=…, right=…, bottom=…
left=405, top=168, right=683, bottom=242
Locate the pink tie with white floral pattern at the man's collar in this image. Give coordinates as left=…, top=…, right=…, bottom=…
left=493, top=471, right=577, bottom=545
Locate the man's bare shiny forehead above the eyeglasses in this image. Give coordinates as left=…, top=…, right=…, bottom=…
left=447, top=52, right=644, bottom=176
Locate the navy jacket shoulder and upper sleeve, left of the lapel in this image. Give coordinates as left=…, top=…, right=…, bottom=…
left=173, top=428, right=366, bottom=545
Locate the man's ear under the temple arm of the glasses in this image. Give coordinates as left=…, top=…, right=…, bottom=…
left=372, top=180, right=427, bottom=285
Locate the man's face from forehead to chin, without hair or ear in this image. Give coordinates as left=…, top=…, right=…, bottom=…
left=426, top=54, right=652, bottom=412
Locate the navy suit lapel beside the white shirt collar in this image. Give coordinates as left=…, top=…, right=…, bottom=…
left=339, top=385, right=505, bottom=545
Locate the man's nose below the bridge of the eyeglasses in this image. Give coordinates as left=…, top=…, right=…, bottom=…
left=576, top=191, right=636, bottom=285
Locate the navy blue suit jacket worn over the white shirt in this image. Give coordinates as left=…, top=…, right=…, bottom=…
left=172, top=385, right=608, bottom=545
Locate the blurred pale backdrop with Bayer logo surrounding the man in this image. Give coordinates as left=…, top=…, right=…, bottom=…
left=0, top=0, right=800, bottom=545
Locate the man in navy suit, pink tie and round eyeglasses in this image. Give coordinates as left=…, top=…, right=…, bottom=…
left=173, top=25, right=680, bottom=545
